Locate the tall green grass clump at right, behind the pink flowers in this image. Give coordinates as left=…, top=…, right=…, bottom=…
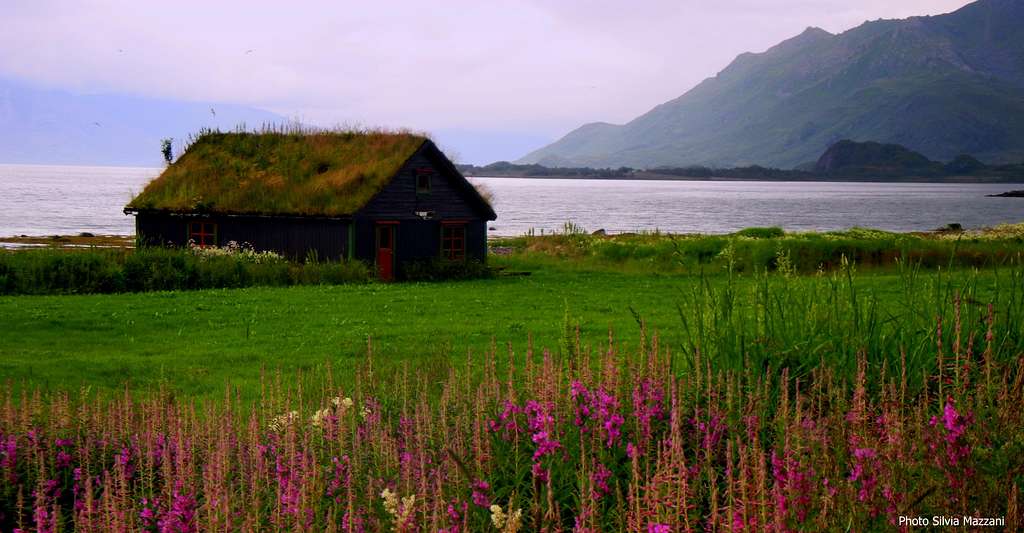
left=675, top=255, right=1024, bottom=382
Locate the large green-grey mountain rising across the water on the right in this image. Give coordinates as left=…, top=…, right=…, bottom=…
left=517, top=0, right=1024, bottom=168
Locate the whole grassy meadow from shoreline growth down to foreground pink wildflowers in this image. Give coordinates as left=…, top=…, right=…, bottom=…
left=0, top=226, right=1024, bottom=533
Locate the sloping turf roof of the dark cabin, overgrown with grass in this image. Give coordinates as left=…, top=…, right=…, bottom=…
left=127, top=131, right=427, bottom=216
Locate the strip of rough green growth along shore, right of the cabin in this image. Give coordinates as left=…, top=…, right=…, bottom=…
left=498, top=225, right=1024, bottom=274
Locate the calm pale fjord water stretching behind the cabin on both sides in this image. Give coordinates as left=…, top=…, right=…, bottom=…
left=0, top=165, right=1024, bottom=236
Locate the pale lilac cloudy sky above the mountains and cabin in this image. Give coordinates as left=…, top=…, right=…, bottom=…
left=0, top=0, right=969, bottom=159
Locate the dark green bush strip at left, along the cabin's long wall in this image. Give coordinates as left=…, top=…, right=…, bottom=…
left=0, top=248, right=371, bottom=295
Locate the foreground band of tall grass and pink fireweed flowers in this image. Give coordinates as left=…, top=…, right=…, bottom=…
left=0, top=272, right=1024, bottom=533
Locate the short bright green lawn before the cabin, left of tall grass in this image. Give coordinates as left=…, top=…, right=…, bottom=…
left=0, top=265, right=693, bottom=394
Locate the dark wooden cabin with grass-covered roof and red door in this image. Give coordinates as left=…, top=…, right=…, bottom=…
left=125, top=132, right=497, bottom=279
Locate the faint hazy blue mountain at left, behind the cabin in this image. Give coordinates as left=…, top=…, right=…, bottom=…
left=0, top=79, right=286, bottom=167
